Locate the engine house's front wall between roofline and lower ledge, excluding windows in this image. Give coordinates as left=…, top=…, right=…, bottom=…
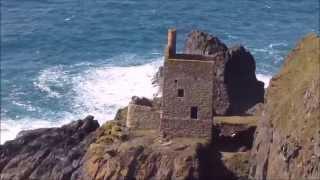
left=162, top=59, right=214, bottom=120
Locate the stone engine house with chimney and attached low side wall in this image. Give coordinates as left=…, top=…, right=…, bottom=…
left=126, top=29, right=215, bottom=139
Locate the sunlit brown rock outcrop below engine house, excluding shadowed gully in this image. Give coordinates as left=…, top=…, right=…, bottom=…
left=79, top=122, right=203, bottom=179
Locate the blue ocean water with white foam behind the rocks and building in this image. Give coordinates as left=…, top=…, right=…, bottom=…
left=0, top=0, right=319, bottom=143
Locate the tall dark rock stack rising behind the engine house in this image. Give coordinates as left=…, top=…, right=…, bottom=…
left=153, top=31, right=264, bottom=115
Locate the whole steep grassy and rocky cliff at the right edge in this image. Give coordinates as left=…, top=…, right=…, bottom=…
left=250, top=34, right=320, bottom=179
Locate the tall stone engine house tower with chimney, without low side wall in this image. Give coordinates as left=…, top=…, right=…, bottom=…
left=160, top=29, right=214, bottom=138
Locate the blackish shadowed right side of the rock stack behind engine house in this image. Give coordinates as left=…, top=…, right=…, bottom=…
left=224, top=46, right=265, bottom=115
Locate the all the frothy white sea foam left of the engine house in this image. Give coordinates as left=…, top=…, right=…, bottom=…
left=0, top=57, right=162, bottom=144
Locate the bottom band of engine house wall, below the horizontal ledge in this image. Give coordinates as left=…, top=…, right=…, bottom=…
left=160, top=119, right=212, bottom=139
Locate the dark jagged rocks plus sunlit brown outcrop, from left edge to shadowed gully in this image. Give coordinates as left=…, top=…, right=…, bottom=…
left=0, top=116, right=207, bottom=180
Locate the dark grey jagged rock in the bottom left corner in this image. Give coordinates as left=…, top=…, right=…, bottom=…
left=0, top=116, right=99, bottom=180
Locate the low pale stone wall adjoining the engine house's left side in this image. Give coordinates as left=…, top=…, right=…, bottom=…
left=127, top=103, right=160, bottom=129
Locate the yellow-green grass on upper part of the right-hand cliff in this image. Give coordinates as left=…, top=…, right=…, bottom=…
left=266, top=34, right=320, bottom=137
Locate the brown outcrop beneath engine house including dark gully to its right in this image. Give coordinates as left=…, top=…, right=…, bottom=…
left=77, top=121, right=254, bottom=180
